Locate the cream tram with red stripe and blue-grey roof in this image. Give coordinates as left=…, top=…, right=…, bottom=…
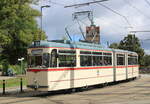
left=27, top=40, right=139, bottom=91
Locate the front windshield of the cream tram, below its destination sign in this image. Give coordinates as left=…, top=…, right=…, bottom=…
left=28, top=53, right=49, bottom=68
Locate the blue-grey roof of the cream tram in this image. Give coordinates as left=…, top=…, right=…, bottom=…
left=29, top=40, right=136, bottom=54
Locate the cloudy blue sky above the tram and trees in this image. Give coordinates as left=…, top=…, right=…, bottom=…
left=33, top=0, right=150, bottom=53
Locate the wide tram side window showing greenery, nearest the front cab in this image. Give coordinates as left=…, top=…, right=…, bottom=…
left=58, top=50, right=76, bottom=67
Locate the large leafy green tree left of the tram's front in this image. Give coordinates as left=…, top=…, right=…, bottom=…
left=0, top=0, right=46, bottom=64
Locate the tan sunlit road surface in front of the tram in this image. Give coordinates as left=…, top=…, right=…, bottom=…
left=0, top=75, right=150, bottom=104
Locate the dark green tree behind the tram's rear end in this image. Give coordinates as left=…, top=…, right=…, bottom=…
left=118, top=34, right=144, bottom=65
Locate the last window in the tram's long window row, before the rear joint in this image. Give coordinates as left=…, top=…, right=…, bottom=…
left=103, top=53, right=112, bottom=66
